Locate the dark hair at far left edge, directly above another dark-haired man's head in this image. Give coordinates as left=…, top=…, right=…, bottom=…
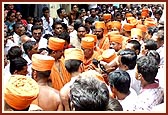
left=7, top=46, right=23, bottom=60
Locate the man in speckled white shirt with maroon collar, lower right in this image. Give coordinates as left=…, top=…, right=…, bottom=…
left=133, top=56, right=164, bottom=111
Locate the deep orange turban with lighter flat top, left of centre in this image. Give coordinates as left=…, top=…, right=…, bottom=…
left=48, top=37, right=65, bottom=51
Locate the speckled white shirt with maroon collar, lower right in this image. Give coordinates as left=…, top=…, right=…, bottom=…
left=133, top=83, right=164, bottom=111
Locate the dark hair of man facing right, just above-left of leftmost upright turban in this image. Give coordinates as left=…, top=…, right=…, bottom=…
left=23, top=41, right=37, bottom=54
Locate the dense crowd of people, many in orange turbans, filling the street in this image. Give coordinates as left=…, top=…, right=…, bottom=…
left=2, top=4, right=166, bottom=112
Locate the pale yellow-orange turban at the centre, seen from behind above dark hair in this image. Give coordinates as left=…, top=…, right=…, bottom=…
left=64, top=48, right=84, bottom=61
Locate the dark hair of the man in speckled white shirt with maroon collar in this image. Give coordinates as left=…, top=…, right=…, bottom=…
left=136, top=56, right=158, bottom=83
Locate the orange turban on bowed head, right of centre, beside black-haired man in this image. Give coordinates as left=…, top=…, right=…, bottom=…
left=101, top=49, right=117, bottom=63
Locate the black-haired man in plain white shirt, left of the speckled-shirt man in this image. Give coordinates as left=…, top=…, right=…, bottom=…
left=109, top=70, right=137, bottom=111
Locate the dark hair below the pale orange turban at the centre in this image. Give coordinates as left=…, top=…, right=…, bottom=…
left=65, top=59, right=82, bottom=73
